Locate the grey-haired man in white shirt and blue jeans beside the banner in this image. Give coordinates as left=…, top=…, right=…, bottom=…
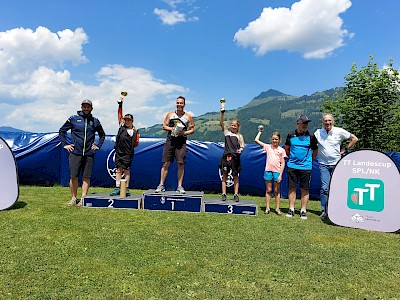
left=314, top=113, right=358, bottom=219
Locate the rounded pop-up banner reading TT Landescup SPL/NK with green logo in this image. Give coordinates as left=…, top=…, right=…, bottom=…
left=328, top=150, right=400, bottom=232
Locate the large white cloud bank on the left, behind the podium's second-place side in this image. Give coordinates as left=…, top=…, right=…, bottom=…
left=0, top=27, right=187, bottom=134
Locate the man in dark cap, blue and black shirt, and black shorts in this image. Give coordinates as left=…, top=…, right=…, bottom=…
left=285, top=115, right=318, bottom=220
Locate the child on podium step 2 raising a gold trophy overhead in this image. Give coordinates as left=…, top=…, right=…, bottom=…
left=110, top=92, right=140, bottom=196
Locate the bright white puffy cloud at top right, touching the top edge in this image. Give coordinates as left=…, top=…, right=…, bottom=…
left=234, top=0, right=353, bottom=58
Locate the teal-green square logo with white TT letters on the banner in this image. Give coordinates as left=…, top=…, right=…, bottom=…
left=347, top=178, right=385, bottom=212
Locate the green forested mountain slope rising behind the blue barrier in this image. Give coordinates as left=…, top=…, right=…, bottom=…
left=140, top=88, right=342, bottom=144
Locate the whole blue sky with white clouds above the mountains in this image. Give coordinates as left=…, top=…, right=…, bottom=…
left=0, top=0, right=400, bottom=134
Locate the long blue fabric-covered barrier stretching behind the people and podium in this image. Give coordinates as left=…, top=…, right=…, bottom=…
left=0, top=132, right=400, bottom=199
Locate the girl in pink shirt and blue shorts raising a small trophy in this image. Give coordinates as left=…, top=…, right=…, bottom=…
left=254, top=126, right=287, bottom=216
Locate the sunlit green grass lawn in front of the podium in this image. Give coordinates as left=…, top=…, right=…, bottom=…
left=0, top=186, right=400, bottom=300
